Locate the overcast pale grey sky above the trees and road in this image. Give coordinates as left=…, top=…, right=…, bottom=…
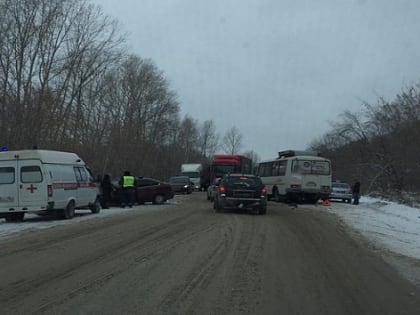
left=93, top=0, right=420, bottom=159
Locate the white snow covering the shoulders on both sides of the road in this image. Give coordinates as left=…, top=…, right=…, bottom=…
left=0, top=195, right=420, bottom=260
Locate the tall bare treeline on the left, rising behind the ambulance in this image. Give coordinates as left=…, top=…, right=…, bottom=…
left=0, top=0, right=223, bottom=179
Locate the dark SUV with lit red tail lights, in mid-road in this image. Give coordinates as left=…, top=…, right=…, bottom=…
left=213, top=174, right=267, bottom=214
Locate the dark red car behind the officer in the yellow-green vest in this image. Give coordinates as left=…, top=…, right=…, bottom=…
left=106, top=177, right=174, bottom=206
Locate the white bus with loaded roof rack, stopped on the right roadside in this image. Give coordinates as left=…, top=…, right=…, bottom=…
left=257, top=150, right=332, bottom=203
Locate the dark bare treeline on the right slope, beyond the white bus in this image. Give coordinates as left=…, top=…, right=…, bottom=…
left=311, top=85, right=420, bottom=199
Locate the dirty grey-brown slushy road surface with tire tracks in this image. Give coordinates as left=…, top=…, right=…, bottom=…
left=0, top=192, right=420, bottom=315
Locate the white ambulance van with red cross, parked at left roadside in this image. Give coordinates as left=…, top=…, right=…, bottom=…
left=0, top=150, right=101, bottom=221
